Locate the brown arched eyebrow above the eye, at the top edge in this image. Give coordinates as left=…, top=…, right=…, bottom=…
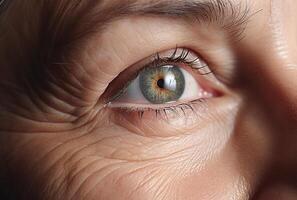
left=49, top=0, right=252, bottom=46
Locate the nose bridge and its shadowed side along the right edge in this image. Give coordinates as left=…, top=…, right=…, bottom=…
left=232, top=0, right=297, bottom=182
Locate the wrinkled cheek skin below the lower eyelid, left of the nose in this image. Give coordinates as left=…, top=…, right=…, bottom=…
left=1, top=108, right=230, bottom=199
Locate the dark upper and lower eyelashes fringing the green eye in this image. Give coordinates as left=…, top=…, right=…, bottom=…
left=106, top=47, right=213, bottom=119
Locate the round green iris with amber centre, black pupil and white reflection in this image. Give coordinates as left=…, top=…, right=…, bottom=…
left=139, top=65, right=185, bottom=104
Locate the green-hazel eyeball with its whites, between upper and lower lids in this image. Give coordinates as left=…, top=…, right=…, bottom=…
left=109, top=49, right=213, bottom=106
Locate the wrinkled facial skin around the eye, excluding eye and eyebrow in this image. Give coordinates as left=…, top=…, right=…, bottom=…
left=0, top=0, right=297, bottom=200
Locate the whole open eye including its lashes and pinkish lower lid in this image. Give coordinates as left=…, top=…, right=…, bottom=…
left=105, top=47, right=221, bottom=135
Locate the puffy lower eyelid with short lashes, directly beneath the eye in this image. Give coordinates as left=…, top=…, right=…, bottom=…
left=109, top=99, right=222, bottom=137
